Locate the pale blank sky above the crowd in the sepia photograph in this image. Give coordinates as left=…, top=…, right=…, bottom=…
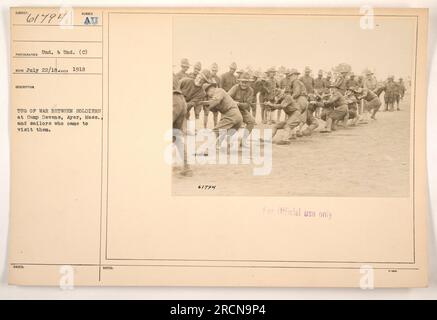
left=173, top=15, right=416, bottom=79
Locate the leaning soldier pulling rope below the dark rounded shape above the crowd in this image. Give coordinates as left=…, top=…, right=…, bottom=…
left=320, top=84, right=348, bottom=133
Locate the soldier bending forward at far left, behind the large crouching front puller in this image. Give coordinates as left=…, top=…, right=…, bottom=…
left=179, top=69, right=211, bottom=128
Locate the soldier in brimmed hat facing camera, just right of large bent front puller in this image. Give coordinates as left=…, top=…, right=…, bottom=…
left=228, top=73, right=255, bottom=146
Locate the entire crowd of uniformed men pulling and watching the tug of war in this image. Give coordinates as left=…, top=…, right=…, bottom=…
left=173, top=59, right=406, bottom=147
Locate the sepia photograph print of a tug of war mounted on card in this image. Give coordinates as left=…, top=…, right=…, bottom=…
left=172, top=14, right=417, bottom=197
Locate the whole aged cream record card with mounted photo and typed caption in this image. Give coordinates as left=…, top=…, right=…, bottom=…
left=9, top=8, right=428, bottom=288
